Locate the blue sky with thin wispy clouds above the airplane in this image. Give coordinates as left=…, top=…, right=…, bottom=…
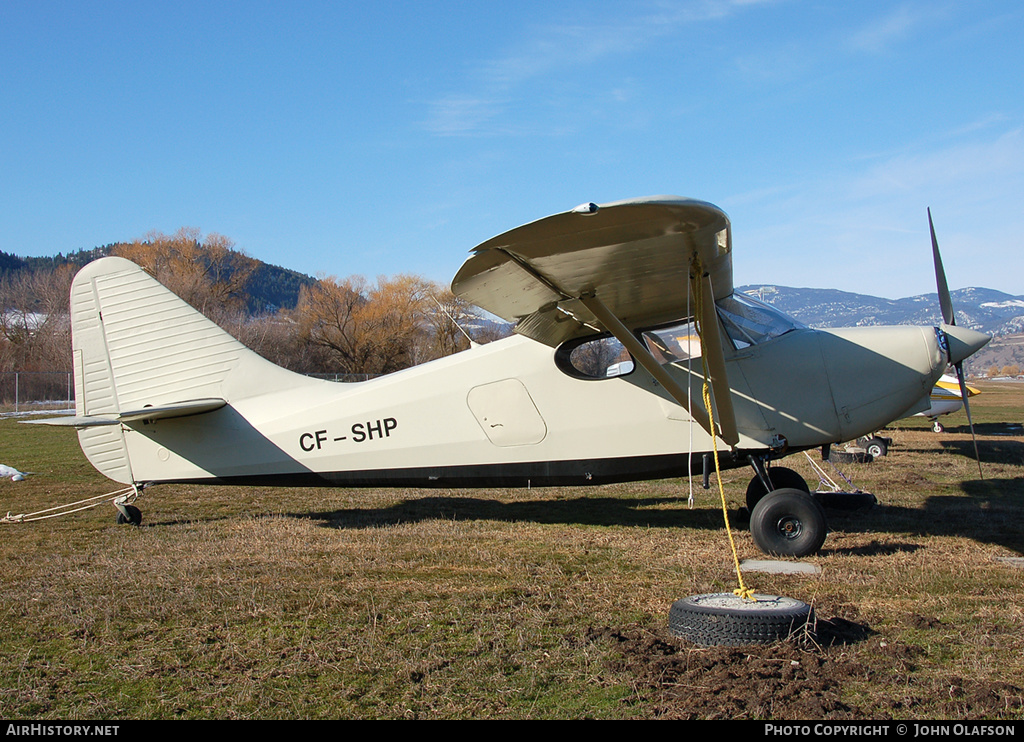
left=0, top=0, right=1024, bottom=298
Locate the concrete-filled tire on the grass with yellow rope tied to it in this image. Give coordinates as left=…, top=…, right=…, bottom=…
left=669, top=593, right=811, bottom=647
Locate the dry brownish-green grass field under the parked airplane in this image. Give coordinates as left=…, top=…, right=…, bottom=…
left=0, top=383, right=1024, bottom=719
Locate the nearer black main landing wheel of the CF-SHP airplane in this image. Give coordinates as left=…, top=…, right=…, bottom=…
left=751, top=489, right=828, bottom=557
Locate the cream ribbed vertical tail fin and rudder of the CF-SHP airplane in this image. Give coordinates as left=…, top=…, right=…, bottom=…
left=70, top=257, right=308, bottom=484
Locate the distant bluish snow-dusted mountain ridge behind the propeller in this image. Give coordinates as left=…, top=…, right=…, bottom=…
left=736, top=285, right=1024, bottom=336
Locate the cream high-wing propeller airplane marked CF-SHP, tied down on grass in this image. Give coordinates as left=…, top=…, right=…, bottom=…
left=36, top=197, right=989, bottom=556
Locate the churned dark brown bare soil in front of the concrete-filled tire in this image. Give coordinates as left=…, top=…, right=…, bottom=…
left=592, top=618, right=1024, bottom=721
